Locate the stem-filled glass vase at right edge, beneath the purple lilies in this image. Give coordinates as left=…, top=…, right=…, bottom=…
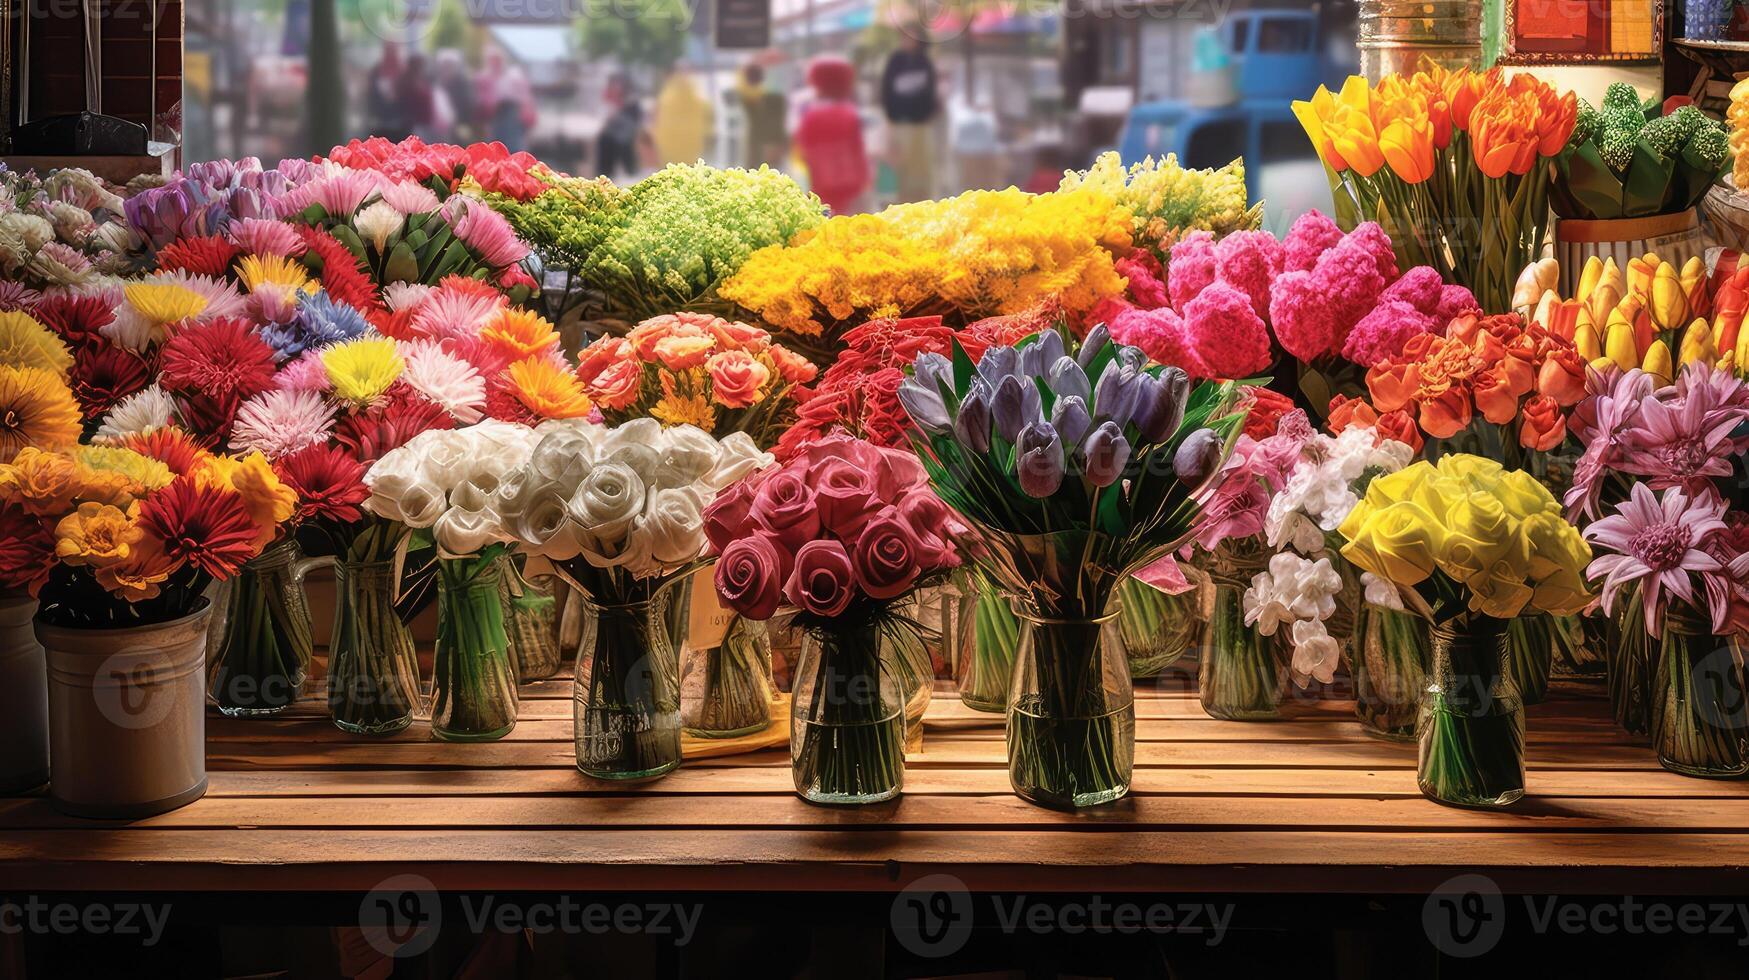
left=1651, top=609, right=1749, bottom=779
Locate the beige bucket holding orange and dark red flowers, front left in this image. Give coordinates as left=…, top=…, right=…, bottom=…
left=37, top=606, right=212, bottom=819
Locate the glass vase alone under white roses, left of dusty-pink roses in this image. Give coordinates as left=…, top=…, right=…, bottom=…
left=572, top=585, right=684, bottom=779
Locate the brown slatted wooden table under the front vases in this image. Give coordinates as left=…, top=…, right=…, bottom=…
left=0, top=672, right=1749, bottom=894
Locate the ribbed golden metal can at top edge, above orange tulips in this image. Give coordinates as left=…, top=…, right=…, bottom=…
left=1357, top=0, right=1481, bottom=84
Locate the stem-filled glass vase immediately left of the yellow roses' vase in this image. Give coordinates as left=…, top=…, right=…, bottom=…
left=1352, top=604, right=1429, bottom=742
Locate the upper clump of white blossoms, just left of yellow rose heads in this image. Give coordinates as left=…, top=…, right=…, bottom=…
left=1263, top=427, right=1415, bottom=555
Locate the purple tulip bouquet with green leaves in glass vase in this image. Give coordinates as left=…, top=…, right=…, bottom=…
left=899, top=327, right=1244, bottom=809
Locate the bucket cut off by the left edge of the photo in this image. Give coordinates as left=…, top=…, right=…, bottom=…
left=0, top=595, right=49, bottom=795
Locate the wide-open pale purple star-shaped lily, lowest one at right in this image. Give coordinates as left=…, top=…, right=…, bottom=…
left=1585, top=483, right=1728, bottom=635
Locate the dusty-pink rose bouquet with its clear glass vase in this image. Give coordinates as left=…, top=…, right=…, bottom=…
left=705, top=434, right=965, bottom=803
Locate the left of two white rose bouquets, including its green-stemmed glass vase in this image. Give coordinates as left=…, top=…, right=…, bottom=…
left=364, top=420, right=537, bottom=742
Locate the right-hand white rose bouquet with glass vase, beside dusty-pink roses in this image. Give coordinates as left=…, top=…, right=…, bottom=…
left=498, top=418, right=771, bottom=779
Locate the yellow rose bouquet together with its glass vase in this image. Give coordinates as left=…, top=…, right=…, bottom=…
left=1336, top=453, right=1592, bottom=807
